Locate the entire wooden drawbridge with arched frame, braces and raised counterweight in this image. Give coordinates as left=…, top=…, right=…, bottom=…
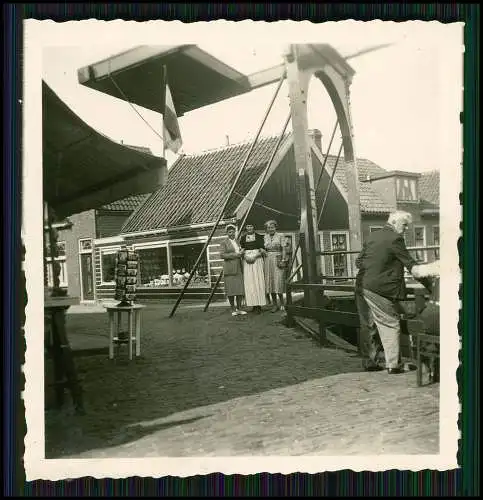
left=79, top=44, right=438, bottom=356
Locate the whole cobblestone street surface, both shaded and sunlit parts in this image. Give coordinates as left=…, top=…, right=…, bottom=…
left=46, top=304, right=439, bottom=458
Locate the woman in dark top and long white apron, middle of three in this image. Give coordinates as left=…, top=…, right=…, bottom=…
left=240, top=224, right=267, bottom=314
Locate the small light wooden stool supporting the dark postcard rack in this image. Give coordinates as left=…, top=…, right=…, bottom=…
left=104, top=304, right=145, bottom=360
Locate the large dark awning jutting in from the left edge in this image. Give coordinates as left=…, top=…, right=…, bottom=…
left=42, top=82, right=167, bottom=218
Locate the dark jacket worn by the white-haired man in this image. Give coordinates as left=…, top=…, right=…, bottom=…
left=356, top=225, right=416, bottom=300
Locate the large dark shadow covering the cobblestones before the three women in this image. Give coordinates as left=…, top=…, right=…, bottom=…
left=45, top=304, right=361, bottom=458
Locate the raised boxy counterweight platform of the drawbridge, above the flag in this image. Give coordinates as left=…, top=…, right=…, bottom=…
left=78, top=45, right=252, bottom=116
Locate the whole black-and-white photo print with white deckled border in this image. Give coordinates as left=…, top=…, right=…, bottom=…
left=22, top=20, right=464, bottom=481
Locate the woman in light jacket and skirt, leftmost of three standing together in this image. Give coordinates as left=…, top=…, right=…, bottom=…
left=220, top=224, right=246, bottom=316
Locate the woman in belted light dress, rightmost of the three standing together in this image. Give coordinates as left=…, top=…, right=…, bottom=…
left=264, top=220, right=288, bottom=312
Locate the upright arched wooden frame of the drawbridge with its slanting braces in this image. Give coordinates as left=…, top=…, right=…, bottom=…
left=166, top=44, right=366, bottom=332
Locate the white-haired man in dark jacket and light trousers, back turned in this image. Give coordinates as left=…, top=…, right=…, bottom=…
left=356, top=211, right=436, bottom=374
